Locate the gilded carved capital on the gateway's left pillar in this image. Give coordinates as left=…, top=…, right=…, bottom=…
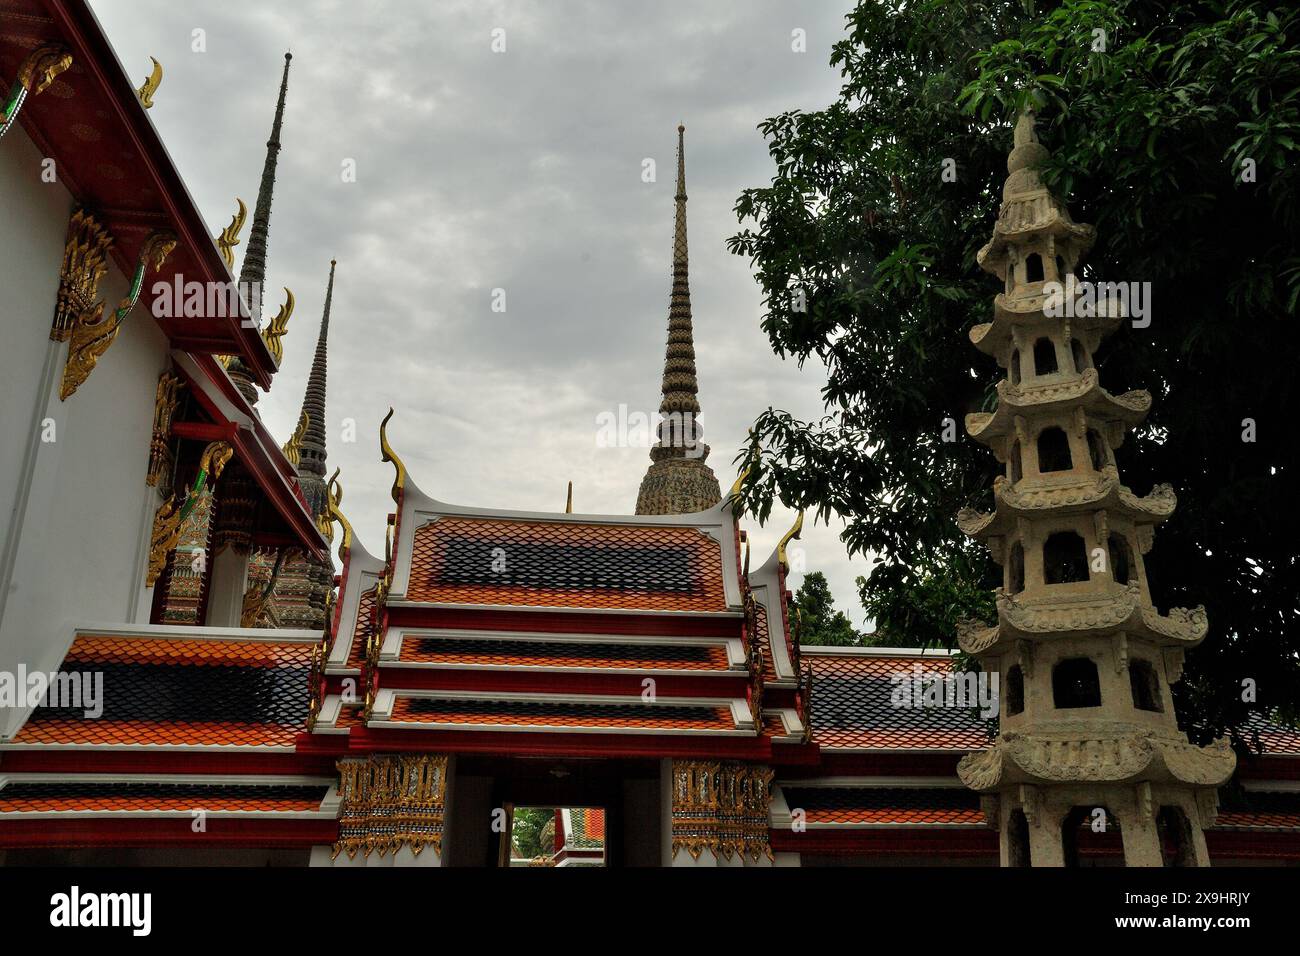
left=334, top=754, right=447, bottom=860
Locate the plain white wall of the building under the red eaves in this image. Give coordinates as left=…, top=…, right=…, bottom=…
left=0, top=119, right=168, bottom=732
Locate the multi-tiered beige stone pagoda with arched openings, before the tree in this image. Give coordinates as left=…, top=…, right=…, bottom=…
left=957, top=112, right=1235, bottom=866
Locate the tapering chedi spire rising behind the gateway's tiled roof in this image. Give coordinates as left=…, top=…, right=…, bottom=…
left=637, top=126, right=722, bottom=515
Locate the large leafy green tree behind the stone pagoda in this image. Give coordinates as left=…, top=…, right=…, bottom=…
left=729, top=0, right=1300, bottom=737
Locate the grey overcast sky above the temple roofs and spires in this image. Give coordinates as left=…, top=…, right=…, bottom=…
left=92, top=0, right=868, bottom=624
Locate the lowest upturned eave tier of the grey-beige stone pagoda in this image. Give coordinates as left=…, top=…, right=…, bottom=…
left=957, top=728, right=1236, bottom=791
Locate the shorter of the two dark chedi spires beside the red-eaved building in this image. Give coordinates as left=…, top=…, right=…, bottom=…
left=274, top=259, right=338, bottom=630
